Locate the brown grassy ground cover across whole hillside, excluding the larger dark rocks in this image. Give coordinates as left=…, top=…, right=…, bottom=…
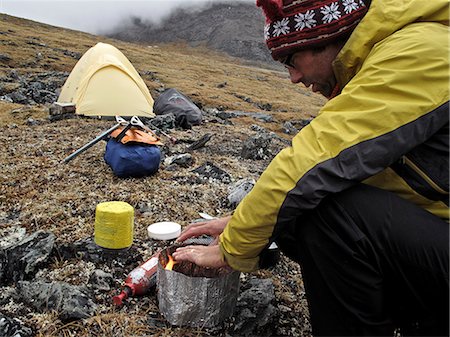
left=0, top=14, right=324, bottom=336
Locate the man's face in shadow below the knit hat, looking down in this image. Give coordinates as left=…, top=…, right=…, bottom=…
left=286, top=44, right=340, bottom=98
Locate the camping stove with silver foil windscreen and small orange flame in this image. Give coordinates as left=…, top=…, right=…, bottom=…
left=157, top=246, right=240, bottom=328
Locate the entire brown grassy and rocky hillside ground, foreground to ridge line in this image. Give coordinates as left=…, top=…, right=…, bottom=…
left=0, top=10, right=324, bottom=337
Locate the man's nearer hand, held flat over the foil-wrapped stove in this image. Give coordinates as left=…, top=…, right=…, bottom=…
left=172, top=244, right=228, bottom=268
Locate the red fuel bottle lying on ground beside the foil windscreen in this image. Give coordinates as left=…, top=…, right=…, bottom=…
left=113, top=252, right=159, bottom=306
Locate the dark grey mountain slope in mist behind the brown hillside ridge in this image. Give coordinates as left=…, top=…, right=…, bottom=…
left=109, top=2, right=273, bottom=64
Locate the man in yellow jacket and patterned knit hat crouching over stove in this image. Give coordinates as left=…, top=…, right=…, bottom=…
left=174, top=0, right=449, bottom=336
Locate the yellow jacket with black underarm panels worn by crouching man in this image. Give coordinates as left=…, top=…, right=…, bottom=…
left=219, top=0, right=450, bottom=271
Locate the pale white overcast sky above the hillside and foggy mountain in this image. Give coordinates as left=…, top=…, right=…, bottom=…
left=0, top=0, right=251, bottom=34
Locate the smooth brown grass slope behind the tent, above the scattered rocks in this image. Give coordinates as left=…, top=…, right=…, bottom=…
left=0, top=15, right=325, bottom=126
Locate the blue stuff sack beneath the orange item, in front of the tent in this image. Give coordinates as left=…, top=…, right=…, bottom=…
left=104, top=138, right=161, bottom=178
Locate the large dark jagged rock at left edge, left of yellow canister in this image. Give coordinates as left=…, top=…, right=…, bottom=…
left=0, top=231, right=55, bottom=283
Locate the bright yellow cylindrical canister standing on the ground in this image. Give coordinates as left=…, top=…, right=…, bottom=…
left=94, top=201, right=134, bottom=249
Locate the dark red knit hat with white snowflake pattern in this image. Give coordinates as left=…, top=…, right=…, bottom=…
left=256, top=0, right=370, bottom=60
